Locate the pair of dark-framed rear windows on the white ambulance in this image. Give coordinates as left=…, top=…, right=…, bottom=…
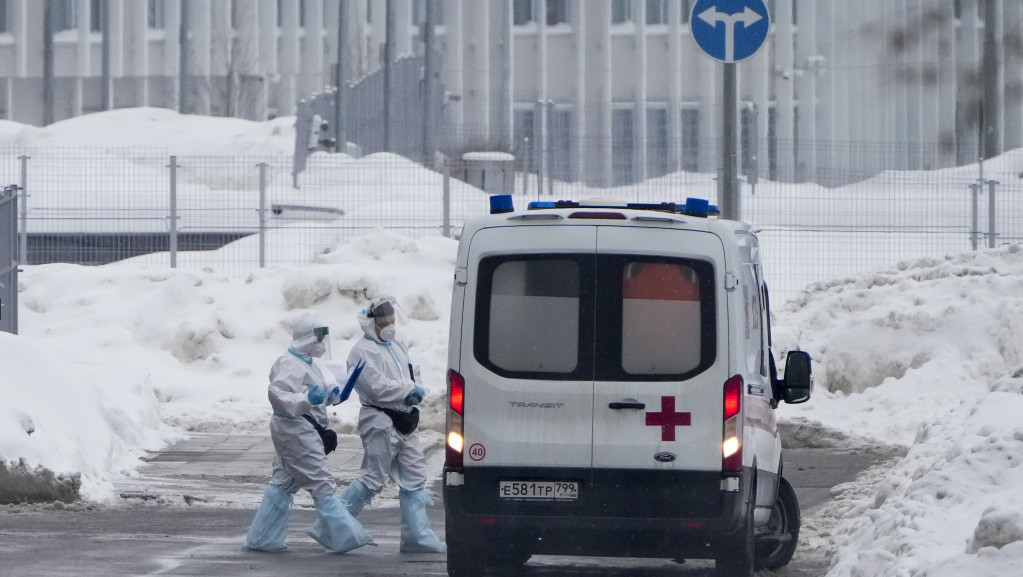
left=473, top=254, right=717, bottom=381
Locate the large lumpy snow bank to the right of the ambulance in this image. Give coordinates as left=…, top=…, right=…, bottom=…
left=775, top=246, right=1023, bottom=577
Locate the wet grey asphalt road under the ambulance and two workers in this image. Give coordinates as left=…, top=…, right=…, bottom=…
left=0, top=436, right=896, bottom=577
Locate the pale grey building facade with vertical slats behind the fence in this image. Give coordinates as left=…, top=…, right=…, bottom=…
left=0, top=0, right=1023, bottom=186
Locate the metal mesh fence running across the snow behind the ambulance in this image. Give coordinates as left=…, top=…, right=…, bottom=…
left=0, top=145, right=1023, bottom=301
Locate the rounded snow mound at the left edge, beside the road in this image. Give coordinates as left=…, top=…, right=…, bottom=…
left=0, top=327, right=169, bottom=502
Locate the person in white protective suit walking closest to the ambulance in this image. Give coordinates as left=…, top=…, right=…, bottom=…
left=341, top=297, right=445, bottom=552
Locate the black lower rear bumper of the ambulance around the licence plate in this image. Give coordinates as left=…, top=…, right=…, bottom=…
left=444, top=468, right=753, bottom=558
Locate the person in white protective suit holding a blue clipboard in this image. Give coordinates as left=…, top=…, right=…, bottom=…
left=246, top=317, right=371, bottom=553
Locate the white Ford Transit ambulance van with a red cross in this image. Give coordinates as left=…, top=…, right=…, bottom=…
left=443, top=195, right=812, bottom=577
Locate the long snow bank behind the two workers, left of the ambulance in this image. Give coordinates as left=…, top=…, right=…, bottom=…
left=0, top=231, right=457, bottom=499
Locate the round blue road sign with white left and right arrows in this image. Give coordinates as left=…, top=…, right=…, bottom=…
left=690, top=0, right=770, bottom=63
